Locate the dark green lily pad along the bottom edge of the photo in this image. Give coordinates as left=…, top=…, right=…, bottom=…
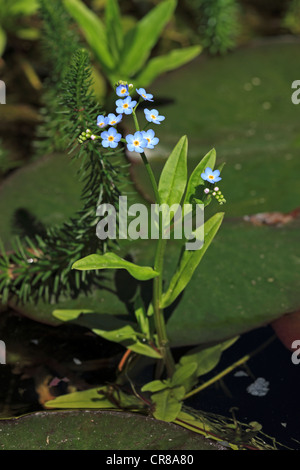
left=0, top=410, right=225, bottom=450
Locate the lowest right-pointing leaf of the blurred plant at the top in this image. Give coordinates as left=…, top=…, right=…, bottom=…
left=135, top=46, right=202, bottom=87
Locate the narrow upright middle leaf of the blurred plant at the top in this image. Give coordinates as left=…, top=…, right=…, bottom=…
left=105, top=0, right=124, bottom=62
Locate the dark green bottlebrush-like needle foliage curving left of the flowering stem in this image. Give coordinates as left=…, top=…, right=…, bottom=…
left=0, top=49, right=125, bottom=302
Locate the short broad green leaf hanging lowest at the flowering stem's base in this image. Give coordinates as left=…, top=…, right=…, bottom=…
left=151, top=387, right=185, bottom=422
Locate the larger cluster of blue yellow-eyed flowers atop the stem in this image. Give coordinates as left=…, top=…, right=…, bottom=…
left=84, top=83, right=165, bottom=153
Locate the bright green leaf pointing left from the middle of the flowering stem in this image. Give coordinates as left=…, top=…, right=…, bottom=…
left=72, top=253, right=158, bottom=281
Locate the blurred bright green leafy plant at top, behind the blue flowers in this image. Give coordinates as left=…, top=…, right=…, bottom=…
left=63, top=0, right=202, bottom=90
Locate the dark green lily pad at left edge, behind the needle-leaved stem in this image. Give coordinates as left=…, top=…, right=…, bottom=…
left=0, top=154, right=81, bottom=249
